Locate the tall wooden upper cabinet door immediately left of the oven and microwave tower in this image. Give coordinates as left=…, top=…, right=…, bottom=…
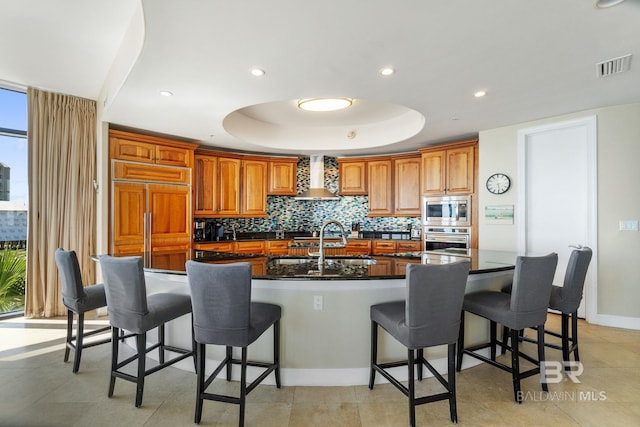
left=393, top=155, right=422, bottom=216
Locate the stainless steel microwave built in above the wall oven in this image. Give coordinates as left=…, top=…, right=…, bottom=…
left=422, top=196, right=471, bottom=227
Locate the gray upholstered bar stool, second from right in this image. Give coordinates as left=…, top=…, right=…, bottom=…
left=457, top=253, right=558, bottom=403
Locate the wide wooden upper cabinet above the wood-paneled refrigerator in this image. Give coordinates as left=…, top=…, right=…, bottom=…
left=109, top=129, right=195, bottom=168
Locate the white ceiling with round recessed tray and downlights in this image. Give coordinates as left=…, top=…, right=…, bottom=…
left=0, top=0, right=640, bottom=155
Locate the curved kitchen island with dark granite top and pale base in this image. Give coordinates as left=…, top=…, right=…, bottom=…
left=135, top=250, right=516, bottom=386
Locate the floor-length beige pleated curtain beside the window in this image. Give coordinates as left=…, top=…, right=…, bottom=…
left=25, top=88, right=96, bottom=317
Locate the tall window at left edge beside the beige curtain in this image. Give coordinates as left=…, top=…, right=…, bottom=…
left=0, top=87, right=29, bottom=314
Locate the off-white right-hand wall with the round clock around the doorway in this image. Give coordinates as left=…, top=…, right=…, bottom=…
left=478, top=104, right=640, bottom=329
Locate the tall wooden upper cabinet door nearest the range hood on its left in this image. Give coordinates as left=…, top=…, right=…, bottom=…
left=240, top=159, right=268, bottom=217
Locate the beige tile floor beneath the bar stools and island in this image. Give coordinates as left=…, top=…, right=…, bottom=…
left=0, top=315, right=640, bottom=427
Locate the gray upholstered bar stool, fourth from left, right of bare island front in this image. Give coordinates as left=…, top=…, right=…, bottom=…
left=369, top=261, right=470, bottom=426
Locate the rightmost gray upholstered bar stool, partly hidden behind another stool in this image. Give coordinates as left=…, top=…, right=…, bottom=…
left=502, top=246, right=593, bottom=371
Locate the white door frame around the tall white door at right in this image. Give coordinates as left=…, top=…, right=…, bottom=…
left=515, top=115, right=598, bottom=322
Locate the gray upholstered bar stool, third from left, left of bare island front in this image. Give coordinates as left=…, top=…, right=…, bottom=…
left=186, top=261, right=282, bottom=426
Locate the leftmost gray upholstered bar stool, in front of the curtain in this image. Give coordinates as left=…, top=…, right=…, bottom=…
left=55, top=248, right=111, bottom=374
